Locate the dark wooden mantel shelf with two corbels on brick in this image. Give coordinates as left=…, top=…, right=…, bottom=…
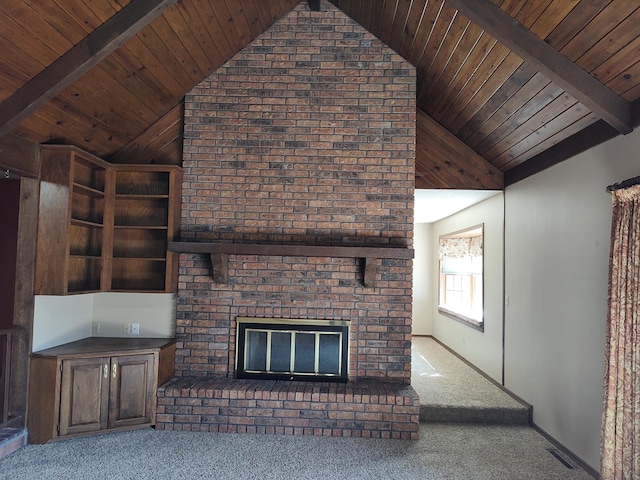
left=168, top=242, right=413, bottom=287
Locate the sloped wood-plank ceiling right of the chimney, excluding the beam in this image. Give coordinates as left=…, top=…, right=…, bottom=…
left=332, top=0, right=640, bottom=181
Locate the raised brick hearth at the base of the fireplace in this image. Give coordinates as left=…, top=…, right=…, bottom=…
left=156, top=377, right=420, bottom=440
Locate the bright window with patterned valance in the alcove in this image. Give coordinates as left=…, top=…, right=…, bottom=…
left=438, top=225, right=484, bottom=330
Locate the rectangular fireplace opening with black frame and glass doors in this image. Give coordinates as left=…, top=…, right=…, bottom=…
left=236, top=317, right=349, bottom=382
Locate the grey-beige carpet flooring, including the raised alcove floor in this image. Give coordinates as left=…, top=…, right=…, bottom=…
left=0, top=338, right=594, bottom=480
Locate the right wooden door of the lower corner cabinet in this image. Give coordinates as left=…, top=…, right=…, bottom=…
left=109, top=353, right=156, bottom=428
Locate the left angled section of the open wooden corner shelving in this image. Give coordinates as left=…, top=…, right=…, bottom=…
left=35, top=145, right=109, bottom=295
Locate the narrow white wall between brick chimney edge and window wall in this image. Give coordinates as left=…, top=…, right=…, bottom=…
left=411, top=223, right=437, bottom=335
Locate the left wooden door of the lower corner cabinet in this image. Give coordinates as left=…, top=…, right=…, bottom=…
left=59, top=357, right=110, bottom=436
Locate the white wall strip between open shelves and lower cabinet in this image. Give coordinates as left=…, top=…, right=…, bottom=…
left=32, top=292, right=176, bottom=352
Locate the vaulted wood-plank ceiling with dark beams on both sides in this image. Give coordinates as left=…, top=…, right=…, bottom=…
left=0, top=0, right=640, bottom=189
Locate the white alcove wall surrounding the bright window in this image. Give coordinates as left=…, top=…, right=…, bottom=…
left=430, top=193, right=504, bottom=382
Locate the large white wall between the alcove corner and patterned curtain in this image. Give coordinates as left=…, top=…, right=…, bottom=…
left=505, top=126, right=640, bottom=469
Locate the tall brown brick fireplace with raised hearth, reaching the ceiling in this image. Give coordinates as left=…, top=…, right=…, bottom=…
left=157, top=0, right=418, bottom=438
